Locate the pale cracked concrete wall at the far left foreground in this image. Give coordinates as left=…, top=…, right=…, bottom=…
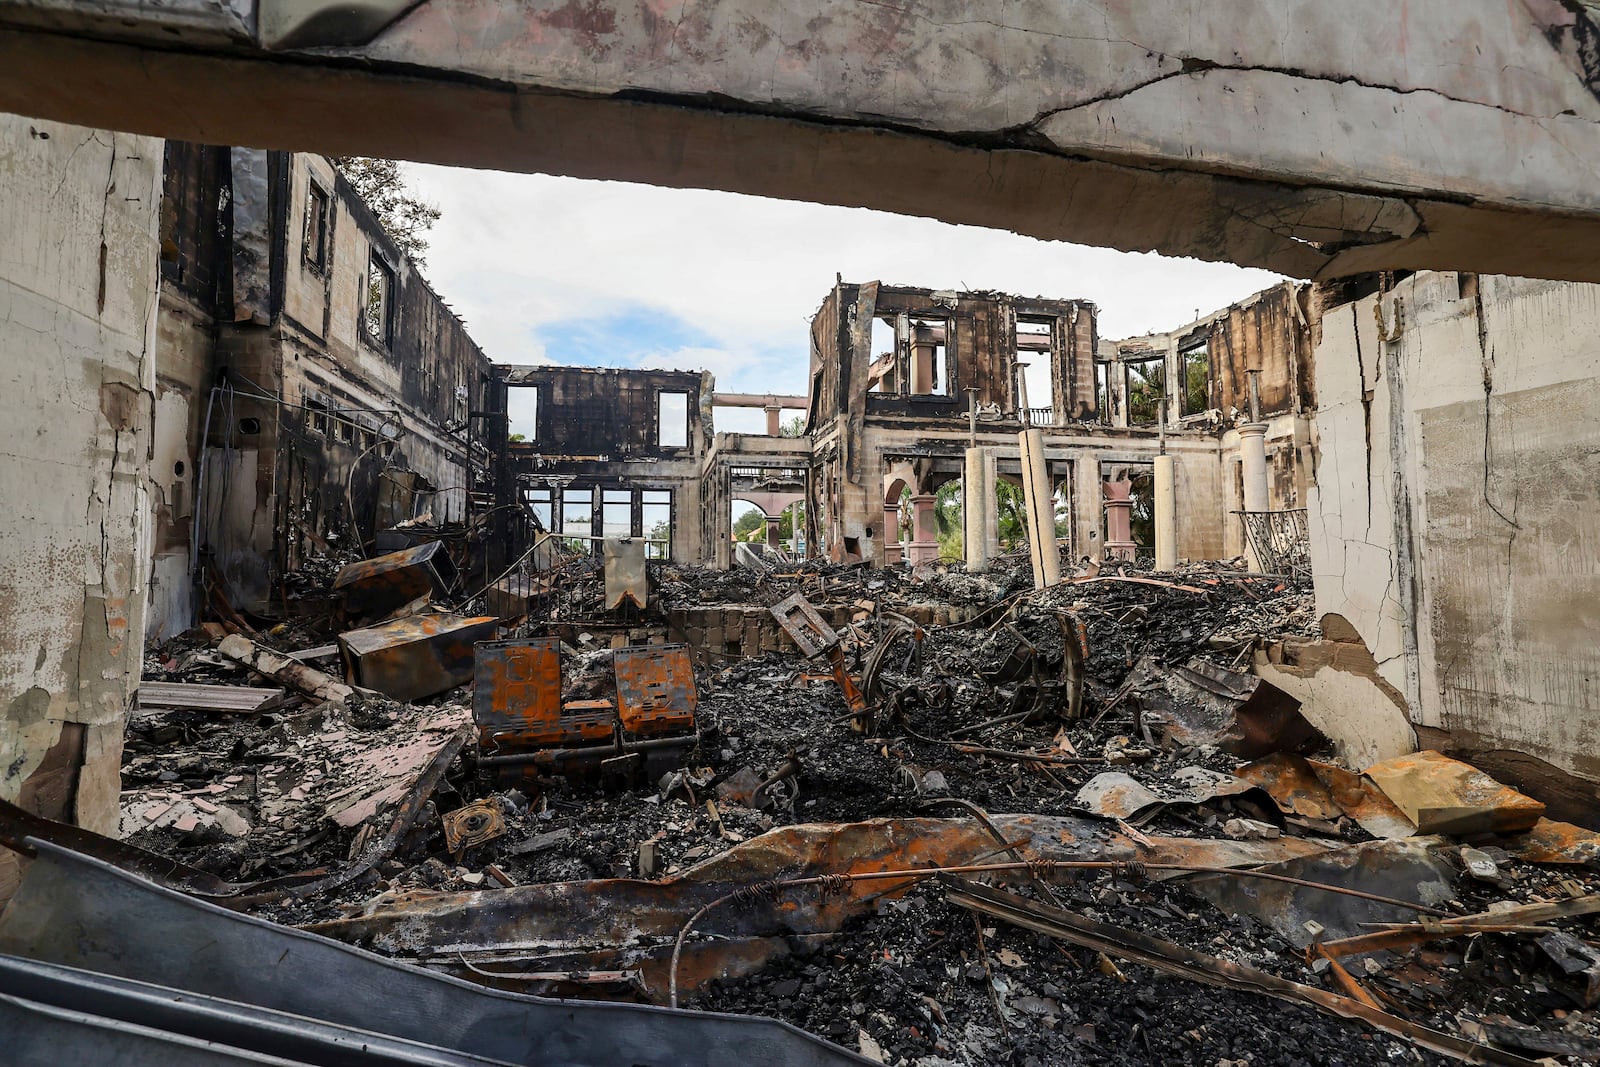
left=0, top=115, right=162, bottom=901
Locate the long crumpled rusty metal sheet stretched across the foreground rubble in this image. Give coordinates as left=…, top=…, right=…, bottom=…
left=314, top=814, right=1325, bottom=1001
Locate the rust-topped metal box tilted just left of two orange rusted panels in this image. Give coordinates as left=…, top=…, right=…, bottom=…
left=339, top=614, right=499, bottom=701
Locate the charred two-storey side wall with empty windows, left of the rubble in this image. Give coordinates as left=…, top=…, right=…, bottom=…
left=152, top=144, right=488, bottom=617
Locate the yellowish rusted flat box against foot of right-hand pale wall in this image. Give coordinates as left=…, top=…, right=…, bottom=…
left=1366, top=752, right=1544, bottom=833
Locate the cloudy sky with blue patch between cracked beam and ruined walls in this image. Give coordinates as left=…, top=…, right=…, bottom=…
left=406, top=165, right=1277, bottom=430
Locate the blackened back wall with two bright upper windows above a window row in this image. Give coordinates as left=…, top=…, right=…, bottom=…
left=491, top=366, right=712, bottom=561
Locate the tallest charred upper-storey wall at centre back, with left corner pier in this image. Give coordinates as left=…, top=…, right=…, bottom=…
left=806, top=282, right=1099, bottom=563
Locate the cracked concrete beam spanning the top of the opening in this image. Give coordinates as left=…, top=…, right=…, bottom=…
left=0, top=0, right=1600, bottom=280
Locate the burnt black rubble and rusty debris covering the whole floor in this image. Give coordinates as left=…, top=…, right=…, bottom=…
left=0, top=541, right=1600, bottom=1067
